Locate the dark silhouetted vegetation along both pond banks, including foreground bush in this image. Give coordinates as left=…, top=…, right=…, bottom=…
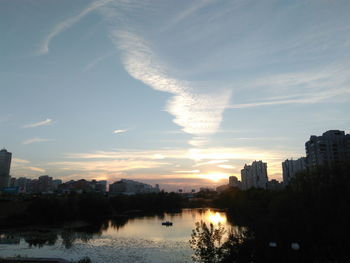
left=0, top=163, right=350, bottom=263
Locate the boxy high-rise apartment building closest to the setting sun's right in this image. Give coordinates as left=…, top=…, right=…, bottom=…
left=241, top=161, right=268, bottom=190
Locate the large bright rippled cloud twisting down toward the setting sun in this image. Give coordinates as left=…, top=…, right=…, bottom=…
left=111, top=31, right=231, bottom=146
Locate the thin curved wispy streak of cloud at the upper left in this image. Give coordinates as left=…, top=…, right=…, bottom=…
left=37, top=0, right=112, bottom=55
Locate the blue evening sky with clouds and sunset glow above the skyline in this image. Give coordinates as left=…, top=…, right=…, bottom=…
left=0, top=0, right=350, bottom=190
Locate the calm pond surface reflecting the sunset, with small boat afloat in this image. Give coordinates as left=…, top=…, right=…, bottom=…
left=0, top=209, right=230, bottom=263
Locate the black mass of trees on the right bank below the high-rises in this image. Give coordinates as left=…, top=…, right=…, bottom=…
left=214, top=163, right=350, bottom=262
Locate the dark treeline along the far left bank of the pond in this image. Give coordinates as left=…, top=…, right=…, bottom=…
left=0, top=192, right=184, bottom=226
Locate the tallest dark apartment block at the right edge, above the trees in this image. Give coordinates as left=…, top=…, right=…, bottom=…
left=305, top=130, right=350, bottom=167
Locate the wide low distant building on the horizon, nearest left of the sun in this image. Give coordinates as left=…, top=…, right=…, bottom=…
left=109, top=179, right=160, bottom=195
